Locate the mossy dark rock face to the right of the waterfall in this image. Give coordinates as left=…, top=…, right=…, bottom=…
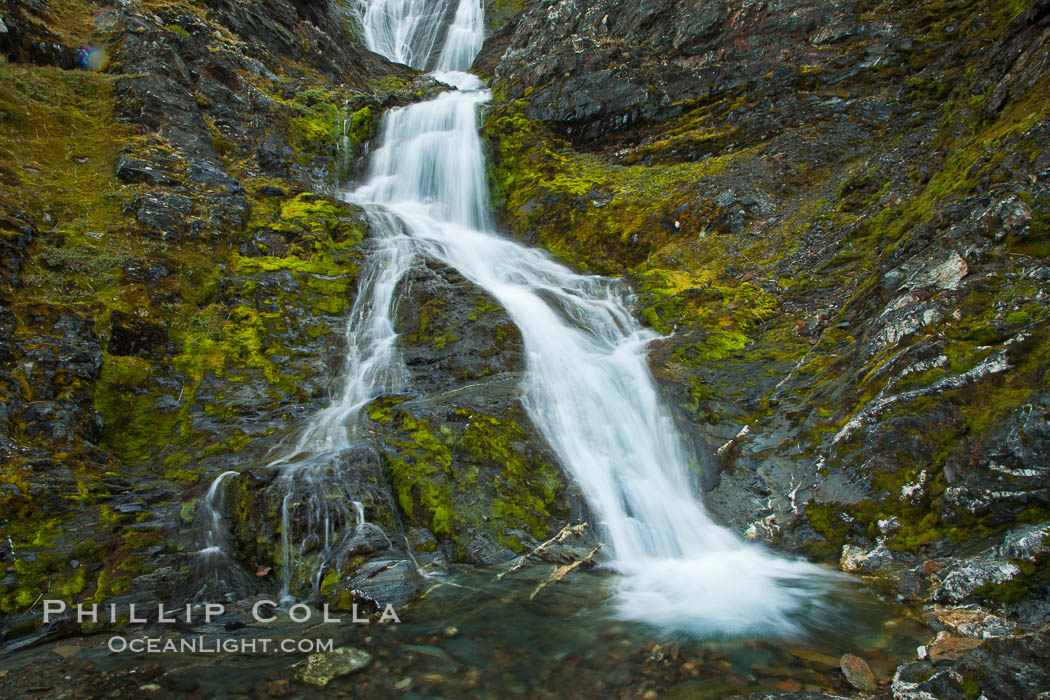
left=476, top=0, right=1050, bottom=697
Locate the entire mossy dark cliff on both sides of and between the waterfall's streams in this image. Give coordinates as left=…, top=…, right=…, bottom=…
left=0, top=0, right=1050, bottom=697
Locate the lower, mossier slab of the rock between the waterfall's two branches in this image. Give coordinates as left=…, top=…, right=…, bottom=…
left=368, top=392, right=570, bottom=564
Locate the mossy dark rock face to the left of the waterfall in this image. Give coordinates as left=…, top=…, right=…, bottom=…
left=0, top=0, right=439, bottom=643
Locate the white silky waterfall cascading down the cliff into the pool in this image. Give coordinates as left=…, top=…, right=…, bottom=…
left=340, top=0, right=827, bottom=635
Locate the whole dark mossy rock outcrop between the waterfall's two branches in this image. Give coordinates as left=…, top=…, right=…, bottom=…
left=368, top=262, right=579, bottom=564
